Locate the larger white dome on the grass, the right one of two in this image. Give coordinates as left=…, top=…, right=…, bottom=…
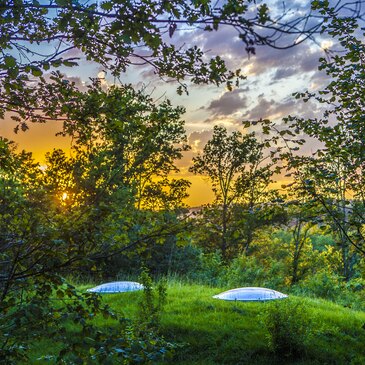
left=213, top=287, right=288, bottom=302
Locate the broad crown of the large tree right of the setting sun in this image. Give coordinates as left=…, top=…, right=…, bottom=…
left=57, top=81, right=189, bottom=208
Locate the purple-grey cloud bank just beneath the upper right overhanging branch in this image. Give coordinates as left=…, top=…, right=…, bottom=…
left=172, top=0, right=323, bottom=81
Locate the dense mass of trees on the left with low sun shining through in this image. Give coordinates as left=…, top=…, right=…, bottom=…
left=2, top=81, right=192, bottom=274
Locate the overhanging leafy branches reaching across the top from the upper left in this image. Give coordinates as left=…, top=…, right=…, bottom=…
left=0, top=0, right=361, bottom=130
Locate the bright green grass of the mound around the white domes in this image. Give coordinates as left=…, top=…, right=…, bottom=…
left=32, top=281, right=365, bottom=365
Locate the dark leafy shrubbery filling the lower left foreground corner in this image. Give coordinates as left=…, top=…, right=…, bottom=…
left=0, top=275, right=174, bottom=364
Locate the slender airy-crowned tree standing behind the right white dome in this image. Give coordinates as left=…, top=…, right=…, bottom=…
left=190, top=126, right=273, bottom=258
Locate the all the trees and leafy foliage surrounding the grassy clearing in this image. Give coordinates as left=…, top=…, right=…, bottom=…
left=0, top=0, right=365, bottom=364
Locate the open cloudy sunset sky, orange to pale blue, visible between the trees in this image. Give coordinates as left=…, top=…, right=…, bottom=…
left=0, top=1, right=331, bottom=206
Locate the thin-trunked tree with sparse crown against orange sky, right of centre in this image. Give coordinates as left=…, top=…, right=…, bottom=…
left=190, top=126, right=276, bottom=259
